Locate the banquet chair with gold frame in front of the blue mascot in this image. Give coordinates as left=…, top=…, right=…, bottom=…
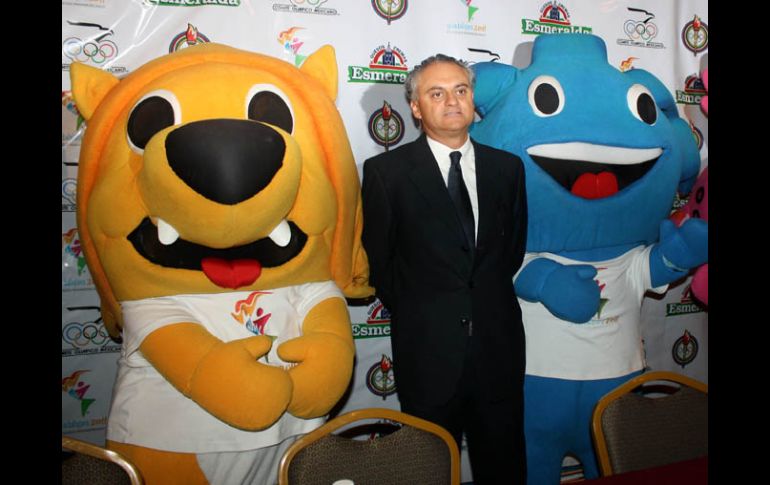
left=591, top=371, right=708, bottom=476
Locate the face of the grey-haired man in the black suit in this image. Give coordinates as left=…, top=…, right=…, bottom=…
left=409, top=62, right=474, bottom=142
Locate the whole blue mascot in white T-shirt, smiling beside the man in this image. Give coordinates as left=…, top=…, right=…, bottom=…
left=464, top=34, right=708, bottom=485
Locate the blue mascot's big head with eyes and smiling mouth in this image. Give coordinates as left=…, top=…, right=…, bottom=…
left=471, top=34, right=700, bottom=260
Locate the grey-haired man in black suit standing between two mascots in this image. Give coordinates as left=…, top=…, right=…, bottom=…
left=363, top=54, right=527, bottom=485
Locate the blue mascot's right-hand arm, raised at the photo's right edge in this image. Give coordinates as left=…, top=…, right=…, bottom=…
left=650, top=219, right=708, bottom=287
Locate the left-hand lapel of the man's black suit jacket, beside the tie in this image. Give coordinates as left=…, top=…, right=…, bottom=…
left=409, top=134, right=465, bottom=246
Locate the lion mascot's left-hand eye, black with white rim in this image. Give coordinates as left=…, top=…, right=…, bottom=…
left=126, top=90, right=180, bottom=153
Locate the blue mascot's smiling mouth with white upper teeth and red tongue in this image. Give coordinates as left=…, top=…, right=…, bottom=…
left=527, top=142, right=663, bottom=199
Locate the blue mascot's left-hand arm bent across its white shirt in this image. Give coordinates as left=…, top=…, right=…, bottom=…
left=514, top=258, right=601, bottom=323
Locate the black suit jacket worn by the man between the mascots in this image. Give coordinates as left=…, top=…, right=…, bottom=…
left=362, top=135, right=527, bottom=405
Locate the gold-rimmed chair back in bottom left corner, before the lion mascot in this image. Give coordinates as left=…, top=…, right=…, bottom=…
left=61, top=436, right=144, bottom=485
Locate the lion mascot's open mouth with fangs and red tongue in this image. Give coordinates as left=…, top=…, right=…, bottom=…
left=128, top=217, right=307, bottom=289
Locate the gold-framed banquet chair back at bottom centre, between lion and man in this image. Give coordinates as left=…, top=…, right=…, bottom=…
left=278, top=408, right=460, bottom=485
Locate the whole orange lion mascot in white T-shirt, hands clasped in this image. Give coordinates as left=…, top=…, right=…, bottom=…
left=71, top=44, right=373, bottom=484
